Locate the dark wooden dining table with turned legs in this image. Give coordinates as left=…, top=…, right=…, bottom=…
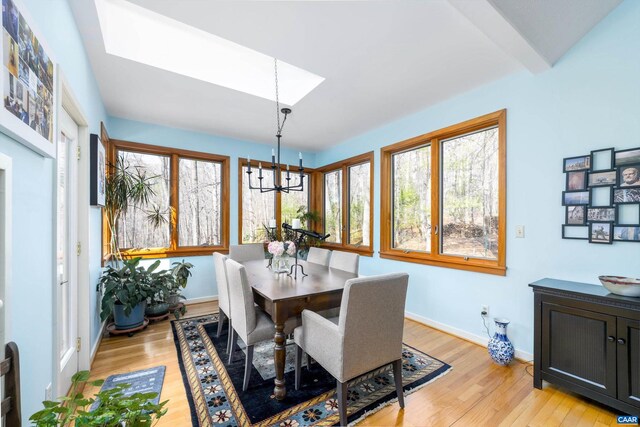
left=241, top=260, right=358, bottom=400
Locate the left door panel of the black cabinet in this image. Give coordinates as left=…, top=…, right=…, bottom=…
left=542, top=303, right=616, bottom=397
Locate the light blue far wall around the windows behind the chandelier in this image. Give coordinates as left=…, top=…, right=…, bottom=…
left=107, top=117, right=315, bottom=308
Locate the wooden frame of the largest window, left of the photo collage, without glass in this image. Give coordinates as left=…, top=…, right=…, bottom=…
left=380, top=109, right=507, bottom=276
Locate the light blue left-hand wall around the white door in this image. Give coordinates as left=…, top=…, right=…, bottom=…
left=0, top=0, right=107, bottom=425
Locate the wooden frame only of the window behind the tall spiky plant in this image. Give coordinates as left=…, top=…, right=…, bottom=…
left=102, top=138, right=230, bottom=261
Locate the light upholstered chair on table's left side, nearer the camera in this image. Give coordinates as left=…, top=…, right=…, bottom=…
left=225, top=259, right=296, bottom=391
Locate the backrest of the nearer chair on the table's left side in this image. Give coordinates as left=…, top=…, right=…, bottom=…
left=225, top=259, right=256, bottom=342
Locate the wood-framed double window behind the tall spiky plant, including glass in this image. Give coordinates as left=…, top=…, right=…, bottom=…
left=103, top=139, right=230, bottom=258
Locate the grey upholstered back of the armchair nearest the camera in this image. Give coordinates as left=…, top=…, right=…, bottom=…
left=338, top=273, right=409, bottom=379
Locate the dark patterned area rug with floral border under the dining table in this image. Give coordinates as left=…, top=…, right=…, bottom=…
left=172, top=314, right=451, bottom=427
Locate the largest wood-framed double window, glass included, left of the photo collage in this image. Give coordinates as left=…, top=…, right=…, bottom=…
left=380, top=110, right=507, bottom=275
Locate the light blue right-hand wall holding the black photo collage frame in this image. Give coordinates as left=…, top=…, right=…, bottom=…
left=316, top=1, right=640, bottom=358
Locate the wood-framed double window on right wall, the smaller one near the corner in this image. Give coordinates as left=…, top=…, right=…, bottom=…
left=316, top=151, right=374, bottom=256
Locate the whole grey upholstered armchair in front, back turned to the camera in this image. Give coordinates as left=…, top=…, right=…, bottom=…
left=292, top=273, right=409, bottom=426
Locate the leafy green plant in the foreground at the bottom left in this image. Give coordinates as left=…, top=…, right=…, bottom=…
left=29, top=371, right=168, bottom=427
